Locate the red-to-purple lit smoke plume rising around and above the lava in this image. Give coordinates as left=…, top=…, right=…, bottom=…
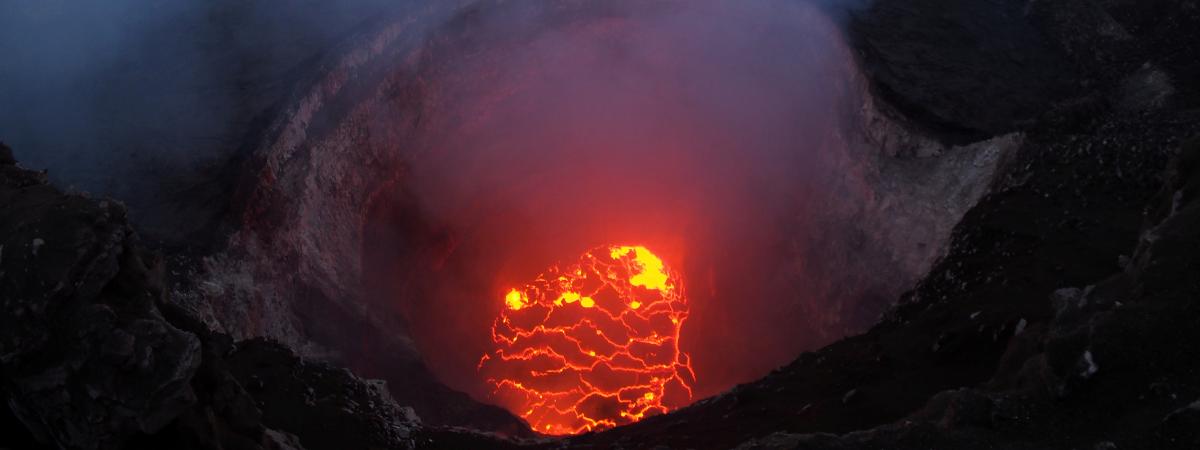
left=368, top=1, right=888, bottom=397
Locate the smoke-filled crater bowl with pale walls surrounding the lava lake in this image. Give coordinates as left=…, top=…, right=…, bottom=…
left=210, top=2, right=1021, bottom=436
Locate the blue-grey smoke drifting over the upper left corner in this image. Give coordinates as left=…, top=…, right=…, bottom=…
left=0, top=0, right=413, bottom=243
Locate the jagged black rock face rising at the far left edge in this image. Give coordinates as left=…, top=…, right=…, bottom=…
left=0, top=146, right=199, bottom=449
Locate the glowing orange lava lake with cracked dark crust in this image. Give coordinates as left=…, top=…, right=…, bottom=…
left=479, top=246, right=696, bottom=434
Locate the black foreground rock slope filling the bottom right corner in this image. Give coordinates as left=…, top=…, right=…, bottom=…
left=742, top=140, right=1200, bottom=449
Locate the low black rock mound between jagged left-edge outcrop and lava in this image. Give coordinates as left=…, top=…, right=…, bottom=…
left=138, top=300, right=419, bottom=450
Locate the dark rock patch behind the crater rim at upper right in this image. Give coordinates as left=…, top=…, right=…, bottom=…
left=848, top=0, right=1080, bottom=143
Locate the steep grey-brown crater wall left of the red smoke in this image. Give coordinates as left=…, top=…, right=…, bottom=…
left=170, top=2, right=528, bottom=434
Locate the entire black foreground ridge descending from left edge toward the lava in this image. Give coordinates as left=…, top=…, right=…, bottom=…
left=0, top=145, right=419, bottom=450
